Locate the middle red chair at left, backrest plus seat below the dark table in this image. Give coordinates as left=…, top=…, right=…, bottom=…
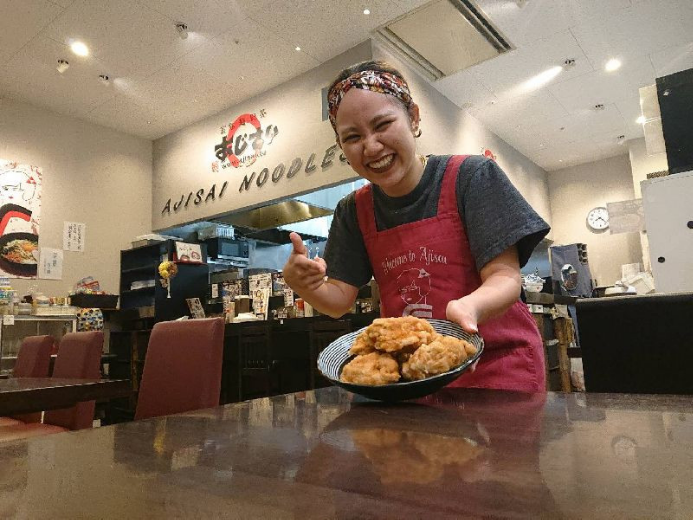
left=0, top=331, right=103, bottom=442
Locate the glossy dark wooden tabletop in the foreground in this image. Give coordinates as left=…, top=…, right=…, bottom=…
left=0, top=388, right=693, bottom=519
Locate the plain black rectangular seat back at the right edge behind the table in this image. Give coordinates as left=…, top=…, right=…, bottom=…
left=576, top=293, right=693, bottom=394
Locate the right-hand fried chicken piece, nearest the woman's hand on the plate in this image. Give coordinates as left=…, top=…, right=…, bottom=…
left=402, top=334, right=467, bottom=380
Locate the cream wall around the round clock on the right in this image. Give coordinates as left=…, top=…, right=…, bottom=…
left=549, top=155, right=642, bottom=285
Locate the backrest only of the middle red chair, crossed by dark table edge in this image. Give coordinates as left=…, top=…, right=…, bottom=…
left=43, top=331, right=103, bottom=430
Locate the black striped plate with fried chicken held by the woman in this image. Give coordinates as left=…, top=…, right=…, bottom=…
left=318, top=316, right=484, bottom=401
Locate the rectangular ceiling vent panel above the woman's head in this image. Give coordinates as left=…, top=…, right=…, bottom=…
left=376, top=0, right=513, bottom=80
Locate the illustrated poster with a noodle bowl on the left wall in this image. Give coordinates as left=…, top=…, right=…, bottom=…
left=0, top=159, right=41, bottom=278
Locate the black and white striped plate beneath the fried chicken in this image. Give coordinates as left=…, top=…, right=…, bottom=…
left=318, top=319, right=484, bottom=401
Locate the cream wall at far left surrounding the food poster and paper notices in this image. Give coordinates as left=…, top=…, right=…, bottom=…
left=0, top=99, right=152, bottom=296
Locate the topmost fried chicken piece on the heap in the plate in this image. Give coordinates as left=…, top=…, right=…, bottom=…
left=365, top=316, right=435, bottom=353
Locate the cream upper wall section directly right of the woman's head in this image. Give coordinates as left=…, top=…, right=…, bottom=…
left=373, top=43, right=552, bottom=233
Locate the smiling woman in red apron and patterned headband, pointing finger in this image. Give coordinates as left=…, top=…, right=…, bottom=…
left=283, top=61, right=549, bottom=392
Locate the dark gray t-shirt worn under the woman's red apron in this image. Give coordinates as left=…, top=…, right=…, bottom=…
left=324, top=155, right=550, bottom=287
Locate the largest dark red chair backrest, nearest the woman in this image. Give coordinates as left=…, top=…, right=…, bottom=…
left=135, top=318, right=224, bottom=419
